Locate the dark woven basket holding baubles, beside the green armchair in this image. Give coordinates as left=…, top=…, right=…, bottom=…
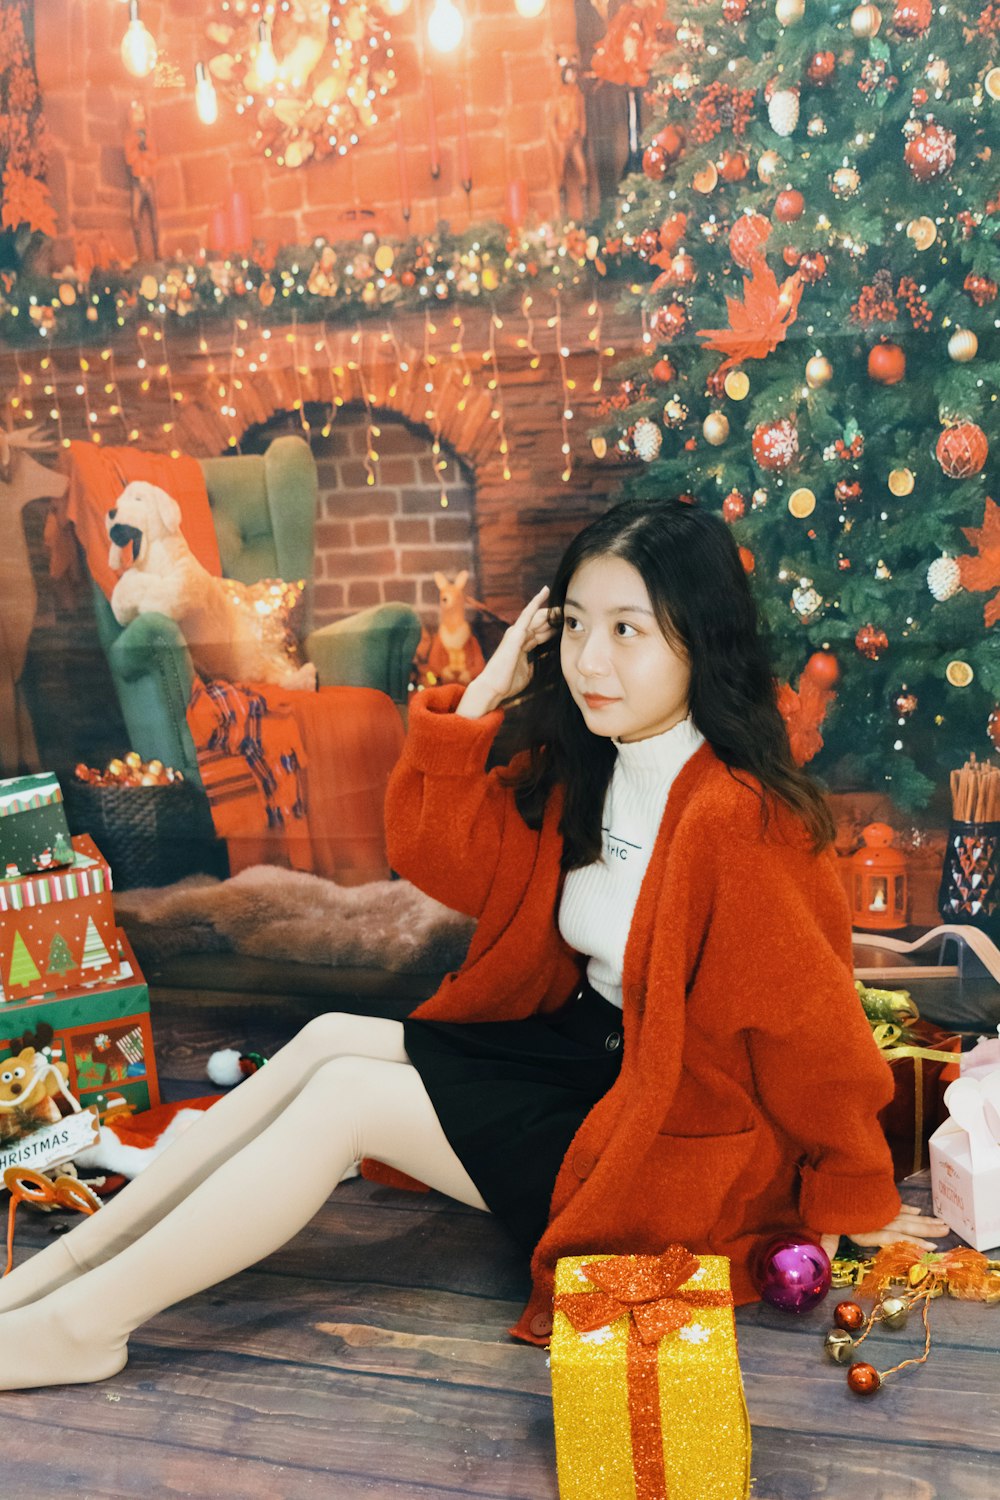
left=63, top=777, right=228, bottom=890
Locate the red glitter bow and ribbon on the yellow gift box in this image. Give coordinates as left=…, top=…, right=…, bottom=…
left=555, top=1245, right=733, bottom=1500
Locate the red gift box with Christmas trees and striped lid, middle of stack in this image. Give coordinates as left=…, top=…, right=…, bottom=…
left=0, top=840, right=117, bottom=1002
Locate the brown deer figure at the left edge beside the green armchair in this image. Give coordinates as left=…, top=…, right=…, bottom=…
left=0, top=428, right=69, bottom=776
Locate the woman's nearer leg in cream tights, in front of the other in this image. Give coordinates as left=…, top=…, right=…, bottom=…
left=0, top=1058, right=486, bottom=1391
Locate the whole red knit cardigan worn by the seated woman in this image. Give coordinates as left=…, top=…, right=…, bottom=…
left=385, top=687, right=900, bottom=1343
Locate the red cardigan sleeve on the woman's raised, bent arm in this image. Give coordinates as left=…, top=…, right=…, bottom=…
left=385, top=686, right=517, bottom=917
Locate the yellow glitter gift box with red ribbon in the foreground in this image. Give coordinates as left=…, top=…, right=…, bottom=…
left=552, top=1245, right=750, bottom=1500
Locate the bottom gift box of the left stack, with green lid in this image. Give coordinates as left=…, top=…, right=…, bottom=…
left=0, top=932, right=159, bottom=1128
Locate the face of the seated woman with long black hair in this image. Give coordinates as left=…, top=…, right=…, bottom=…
left=559, top=555, right=691, bottom=741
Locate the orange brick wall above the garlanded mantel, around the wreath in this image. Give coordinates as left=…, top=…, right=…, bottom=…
left=36, top=0, right=574, bottom=264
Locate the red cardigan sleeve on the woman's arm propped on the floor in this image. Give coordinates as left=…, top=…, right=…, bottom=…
left=717, top=836, right=900, bottom=1233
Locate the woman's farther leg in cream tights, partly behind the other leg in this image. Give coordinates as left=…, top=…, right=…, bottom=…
left=0, top=1011, right=406, bottom=1313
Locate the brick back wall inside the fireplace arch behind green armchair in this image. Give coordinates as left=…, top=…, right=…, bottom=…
left=312, top=408, right=478, bottom=626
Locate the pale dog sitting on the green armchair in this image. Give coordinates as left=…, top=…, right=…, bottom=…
left=105, top=480, right=316, bottom=689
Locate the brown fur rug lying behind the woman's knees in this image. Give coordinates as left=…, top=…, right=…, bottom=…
left=114, top=864, right=474, bottom=974
